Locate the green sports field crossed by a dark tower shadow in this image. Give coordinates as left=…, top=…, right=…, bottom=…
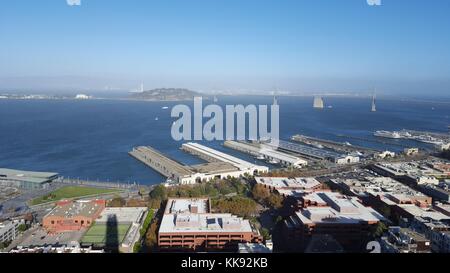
left=81, top=223, right=131, bottom=246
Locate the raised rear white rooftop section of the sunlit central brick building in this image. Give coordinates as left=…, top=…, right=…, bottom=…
left=164, top=198, right=209, bottom=214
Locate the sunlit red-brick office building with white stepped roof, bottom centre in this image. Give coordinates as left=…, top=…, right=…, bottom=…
left=158, top=199, right=262, bottom=251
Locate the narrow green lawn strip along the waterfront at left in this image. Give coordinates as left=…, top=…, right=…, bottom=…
left=31, top=186, right=120, bottom=205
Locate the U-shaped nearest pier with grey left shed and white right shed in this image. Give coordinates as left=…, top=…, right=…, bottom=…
left=129, top=143, right=269, bottom=184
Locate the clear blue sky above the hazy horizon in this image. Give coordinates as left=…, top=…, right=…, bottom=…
left=0, top=0, right=450, bottom=94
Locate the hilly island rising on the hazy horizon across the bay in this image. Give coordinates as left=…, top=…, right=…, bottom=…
left=132, top=88, right=203, bottom=101
